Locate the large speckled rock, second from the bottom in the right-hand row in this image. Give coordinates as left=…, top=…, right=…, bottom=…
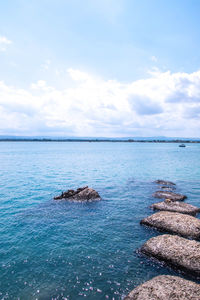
left=141, top=234, right=200, bottom=276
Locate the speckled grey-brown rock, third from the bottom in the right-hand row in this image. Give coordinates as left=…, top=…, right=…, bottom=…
left=140, top=211, right=200, bottom=239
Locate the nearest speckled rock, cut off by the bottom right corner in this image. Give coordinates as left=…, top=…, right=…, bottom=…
left=124, top=275, right=200, bottom=300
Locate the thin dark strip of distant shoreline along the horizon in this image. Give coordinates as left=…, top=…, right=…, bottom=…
left=0, top=138, right=200, bottom=144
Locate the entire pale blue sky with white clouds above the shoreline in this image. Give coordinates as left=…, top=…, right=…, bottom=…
left=0, top=0, right=200, bottom=138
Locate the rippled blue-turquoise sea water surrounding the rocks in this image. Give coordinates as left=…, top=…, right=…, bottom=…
left=0, top=142, right=200, bottom=300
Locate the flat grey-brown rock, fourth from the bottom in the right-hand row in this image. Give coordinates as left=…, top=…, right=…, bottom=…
left=150, top=199, right=200, bottom=216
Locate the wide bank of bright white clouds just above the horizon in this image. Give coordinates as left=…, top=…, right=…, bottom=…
left=0, top=69, right=200, bottom=137
